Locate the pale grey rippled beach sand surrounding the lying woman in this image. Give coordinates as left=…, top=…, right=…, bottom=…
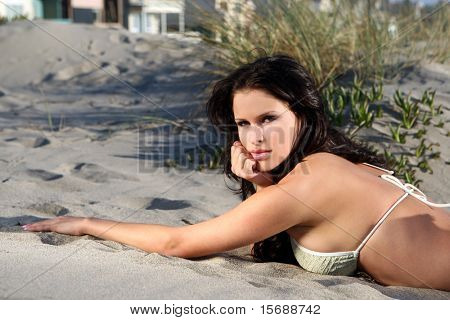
left=0, top=21, right=450, bottom=299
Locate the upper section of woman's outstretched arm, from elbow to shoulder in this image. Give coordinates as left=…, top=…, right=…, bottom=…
left=167, top=176, right=315, bottom=258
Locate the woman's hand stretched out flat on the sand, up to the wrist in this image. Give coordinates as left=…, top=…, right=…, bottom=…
left=22, top=216, right=87, bottom=236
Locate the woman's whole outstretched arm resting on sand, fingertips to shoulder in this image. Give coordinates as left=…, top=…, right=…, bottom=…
left=27, top=161, right=320, bottom=258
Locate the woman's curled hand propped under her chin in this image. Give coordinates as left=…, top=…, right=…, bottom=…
left=231, top=141, right=273, bottom=187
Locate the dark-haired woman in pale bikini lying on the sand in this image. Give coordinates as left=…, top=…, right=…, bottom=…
left=23, top=55, right=450, bottom=290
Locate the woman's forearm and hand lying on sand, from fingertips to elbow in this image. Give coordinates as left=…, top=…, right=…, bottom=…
left=23, top=216, right=175, bottom=254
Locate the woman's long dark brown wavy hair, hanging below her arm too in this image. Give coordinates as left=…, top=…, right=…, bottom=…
left=206, top=54, right=390, bottom=265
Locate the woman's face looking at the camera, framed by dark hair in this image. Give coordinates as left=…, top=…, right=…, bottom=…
left=233, top=89, right=298, bottom=172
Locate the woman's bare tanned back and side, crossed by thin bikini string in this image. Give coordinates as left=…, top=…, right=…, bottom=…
left=288, top=153, right=450, bottom=290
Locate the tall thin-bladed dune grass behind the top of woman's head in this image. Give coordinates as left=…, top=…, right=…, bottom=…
left=199, top=0, right=450, bottom=88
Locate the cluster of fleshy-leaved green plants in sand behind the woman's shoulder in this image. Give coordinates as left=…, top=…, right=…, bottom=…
left=321, top=77, right=442, bottom=185
